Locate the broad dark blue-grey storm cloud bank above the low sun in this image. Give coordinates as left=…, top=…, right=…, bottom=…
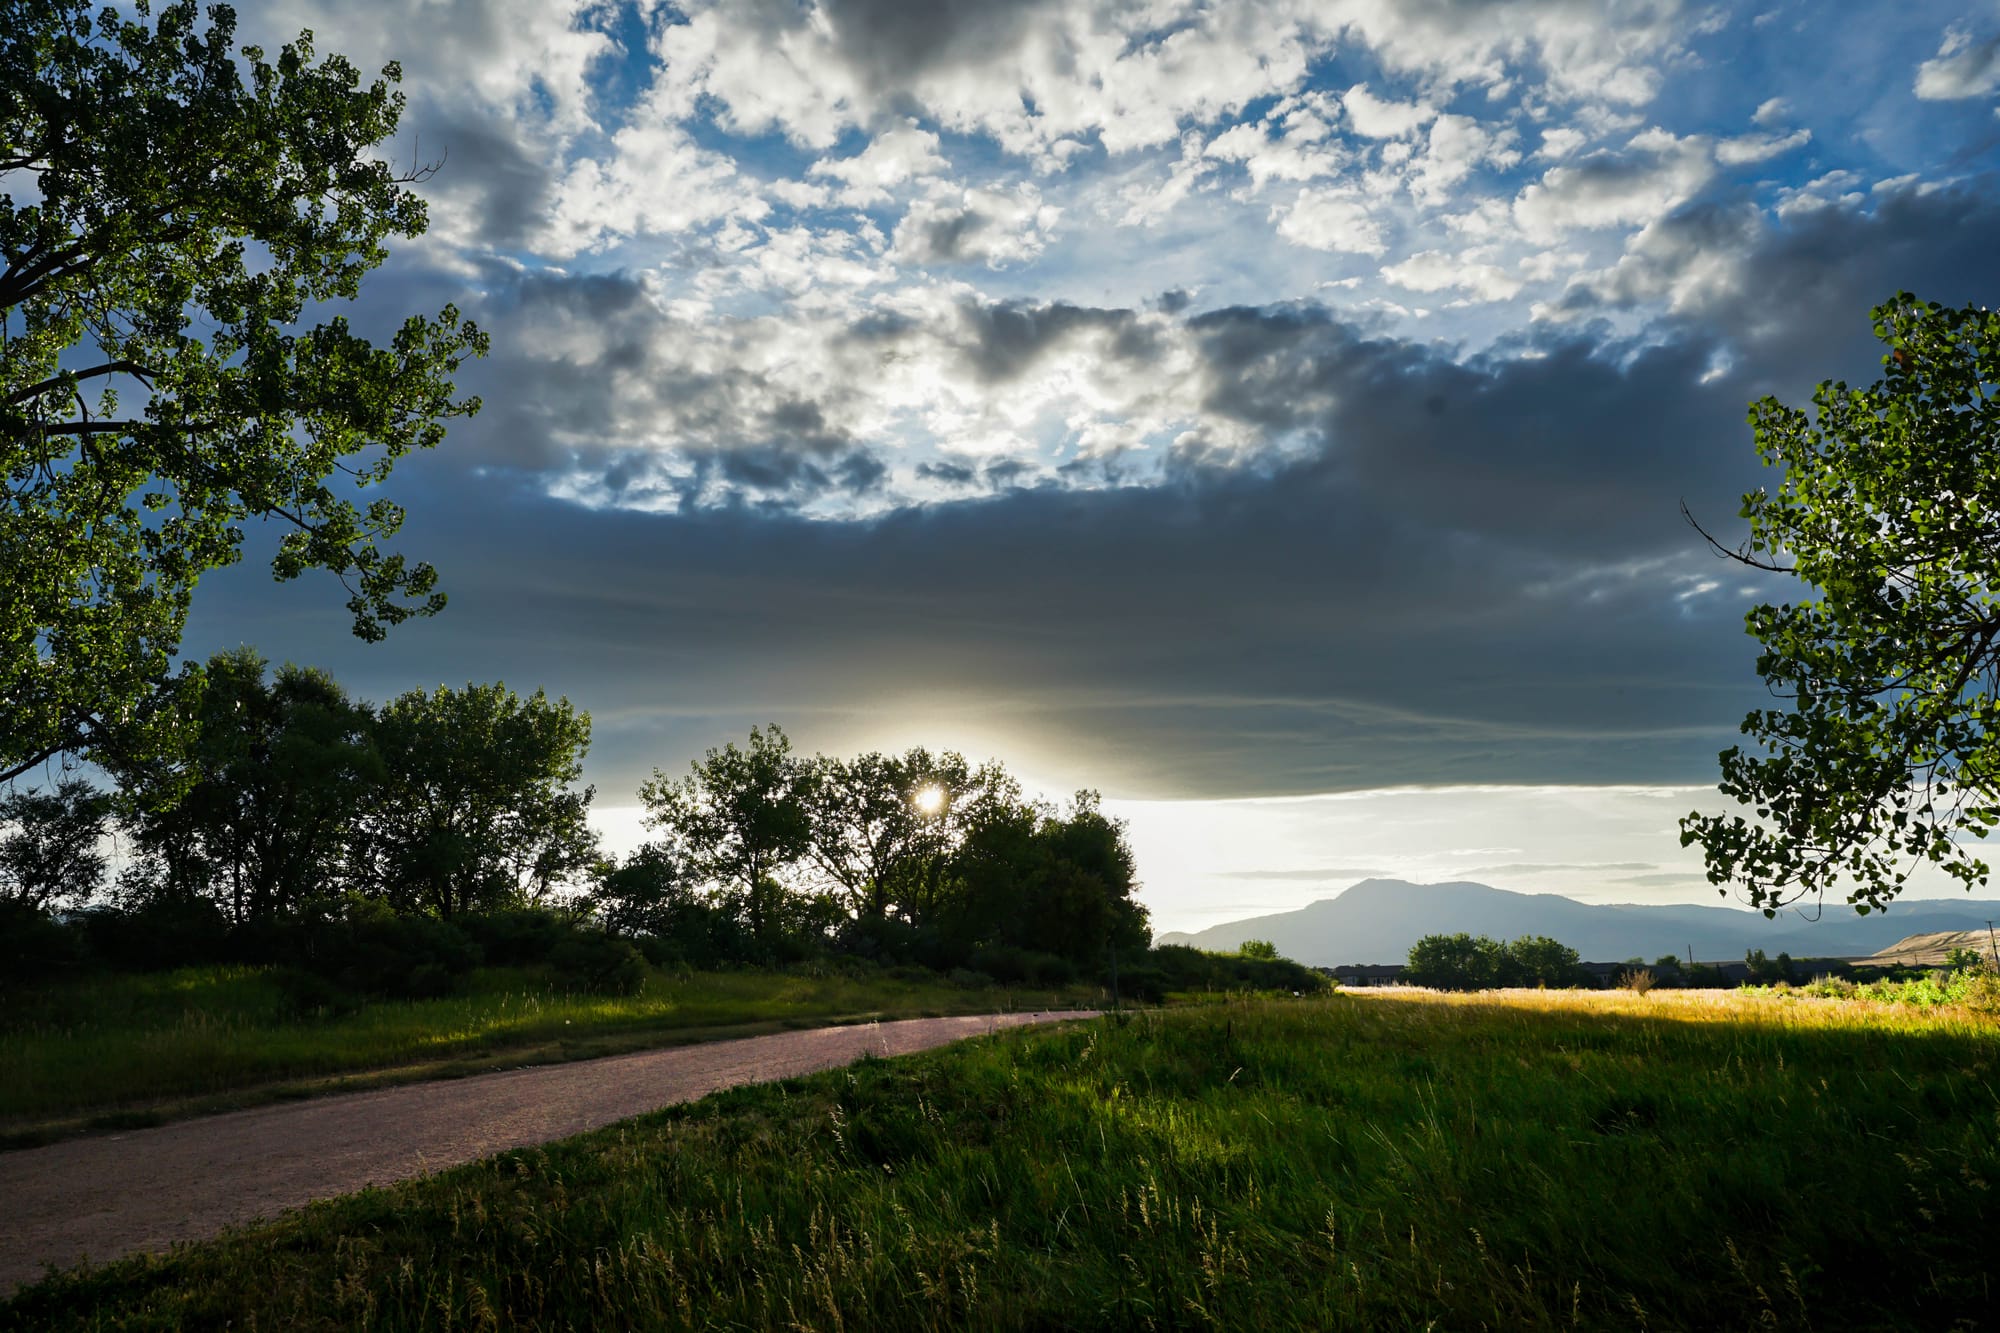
left=192, top=194, right=2000, bottom=799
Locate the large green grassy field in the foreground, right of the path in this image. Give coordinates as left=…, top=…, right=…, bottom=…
left=0, top=980, right=2000, bottom=1329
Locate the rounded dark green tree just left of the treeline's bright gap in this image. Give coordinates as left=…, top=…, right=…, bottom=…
left=362, top=683, right=598, bottom=919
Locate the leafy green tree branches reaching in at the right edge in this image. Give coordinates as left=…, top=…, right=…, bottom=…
left=1680, top=292, right=2000, bottom=915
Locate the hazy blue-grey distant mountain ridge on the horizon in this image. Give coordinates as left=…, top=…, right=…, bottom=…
left=1158, top=879, right=2000, bottom=967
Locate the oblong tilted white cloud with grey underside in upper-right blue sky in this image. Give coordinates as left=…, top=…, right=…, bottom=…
left=1514, top=130, right=1714, bottom=240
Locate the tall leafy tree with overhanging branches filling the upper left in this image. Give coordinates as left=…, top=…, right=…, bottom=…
left=0, top=0, right=486, bottom=781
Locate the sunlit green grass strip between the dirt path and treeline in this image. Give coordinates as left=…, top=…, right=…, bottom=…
left=0, top=967, right=1096, bottom=1145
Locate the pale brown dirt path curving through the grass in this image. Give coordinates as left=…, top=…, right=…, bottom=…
left=0, top=1011, right=1092, bottom=1297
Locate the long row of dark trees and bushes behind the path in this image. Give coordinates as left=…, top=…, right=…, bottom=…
left=0, top=648, right=1318, bottom=995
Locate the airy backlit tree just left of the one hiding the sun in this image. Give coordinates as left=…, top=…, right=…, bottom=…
left=638, top=727, right=812, bottom=943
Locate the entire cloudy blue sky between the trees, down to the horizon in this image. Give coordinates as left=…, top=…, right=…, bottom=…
left=176, top=0, right=2000, bottom=929
